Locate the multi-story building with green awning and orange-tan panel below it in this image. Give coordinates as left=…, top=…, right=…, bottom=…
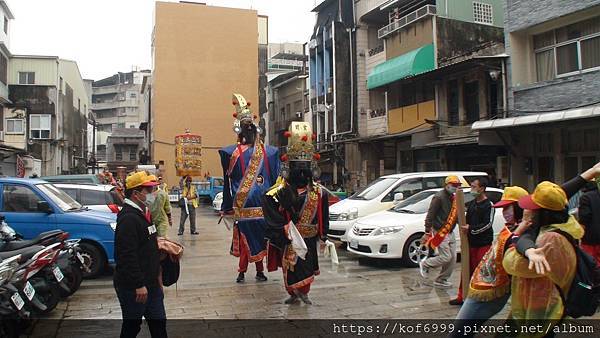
left=324, top=0, right=506, bottom=190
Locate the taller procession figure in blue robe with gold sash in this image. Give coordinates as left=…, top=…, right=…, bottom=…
left=219, top=94, right=279, bottom=283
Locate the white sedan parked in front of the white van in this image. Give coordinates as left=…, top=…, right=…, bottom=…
left=348, top=188, right=504, bottom=267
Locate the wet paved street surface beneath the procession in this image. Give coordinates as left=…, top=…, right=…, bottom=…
left=30, top=202, right=506, bottom=332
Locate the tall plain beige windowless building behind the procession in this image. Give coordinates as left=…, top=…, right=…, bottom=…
left=149, top=2, right=268, bottom=186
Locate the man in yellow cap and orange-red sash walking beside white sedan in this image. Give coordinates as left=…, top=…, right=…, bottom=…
left=419, top=176, right=461, bottom=288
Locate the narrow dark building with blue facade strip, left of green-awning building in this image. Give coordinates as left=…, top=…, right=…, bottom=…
left=308, top=0, right=357, bottom=183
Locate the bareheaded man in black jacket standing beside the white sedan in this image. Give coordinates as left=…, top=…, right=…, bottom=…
left=449, top=178, right=494, bottom=305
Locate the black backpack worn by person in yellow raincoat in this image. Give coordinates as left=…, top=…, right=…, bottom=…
left=554, top=230, right=600, bottom=318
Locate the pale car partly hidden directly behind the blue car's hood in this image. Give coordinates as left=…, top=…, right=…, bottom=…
left=54, top=183, right=122, bottom=214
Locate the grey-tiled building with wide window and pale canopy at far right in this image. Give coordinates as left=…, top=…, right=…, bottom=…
left=473, top=0, right=600, bottom=188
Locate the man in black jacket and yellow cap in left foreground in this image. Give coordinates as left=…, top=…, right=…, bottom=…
left=114, top=172, right=167, bottom=338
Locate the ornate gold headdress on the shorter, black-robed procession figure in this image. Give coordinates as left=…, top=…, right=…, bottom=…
left=281, top=122, right=321, bottom=178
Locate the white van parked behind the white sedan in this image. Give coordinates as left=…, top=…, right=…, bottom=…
left=328, top=171, right=487, bottom=242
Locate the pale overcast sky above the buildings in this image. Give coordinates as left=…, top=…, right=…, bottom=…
left=7, top=0, right=315, bottom=80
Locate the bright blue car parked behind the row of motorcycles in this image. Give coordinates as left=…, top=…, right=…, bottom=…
left=0, top=177, right=117, bottom=277
